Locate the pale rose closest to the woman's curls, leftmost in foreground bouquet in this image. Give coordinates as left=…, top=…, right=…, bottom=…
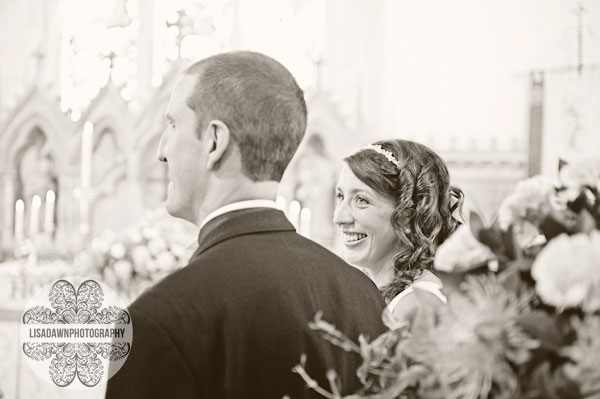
left=433, top=224, right=495, bottom=272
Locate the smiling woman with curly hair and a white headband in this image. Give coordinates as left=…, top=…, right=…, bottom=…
left=334, top=140, right=463, bottom=319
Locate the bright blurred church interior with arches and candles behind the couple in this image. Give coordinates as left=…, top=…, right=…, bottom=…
left=0, top=0, right=600, bottom=397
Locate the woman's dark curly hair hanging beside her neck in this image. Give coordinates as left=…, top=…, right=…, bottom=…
left=344, top=140, right=464, bottom=300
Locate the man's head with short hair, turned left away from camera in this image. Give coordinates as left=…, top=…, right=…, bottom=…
left=159, top=52, right=306, bottom=222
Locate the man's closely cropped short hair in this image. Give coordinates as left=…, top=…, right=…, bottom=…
left=185, top=51, right=306, bottom=181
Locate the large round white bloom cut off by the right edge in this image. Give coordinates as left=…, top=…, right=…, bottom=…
left=531, top=231, right=600, bottom=309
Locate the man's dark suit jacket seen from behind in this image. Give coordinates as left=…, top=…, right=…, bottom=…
left=107, top=208, right=385, bottom=399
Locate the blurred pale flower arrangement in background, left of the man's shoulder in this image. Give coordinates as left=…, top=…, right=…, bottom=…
left=88, top=209, right=195, bottom=298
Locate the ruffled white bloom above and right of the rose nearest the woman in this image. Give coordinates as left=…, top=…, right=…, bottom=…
left=498, top=176, right=555, bottom=230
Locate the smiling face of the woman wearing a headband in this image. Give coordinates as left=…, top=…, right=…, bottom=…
left=333, top=165, right=399, bottom=271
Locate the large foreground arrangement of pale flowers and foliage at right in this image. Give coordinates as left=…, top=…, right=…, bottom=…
left=294, top=157, right=600, bottom=399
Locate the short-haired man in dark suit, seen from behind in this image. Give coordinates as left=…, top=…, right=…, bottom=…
left=106, top=52, right=384, bottom=399
